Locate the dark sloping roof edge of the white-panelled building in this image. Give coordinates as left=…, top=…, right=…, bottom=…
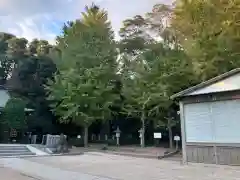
left=170, top=68, right=240, bottom=99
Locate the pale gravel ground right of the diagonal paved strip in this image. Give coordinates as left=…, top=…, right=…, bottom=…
left=19, top=152, right=240, bottom=180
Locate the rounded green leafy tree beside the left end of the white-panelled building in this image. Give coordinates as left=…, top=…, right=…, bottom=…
left=123, top=43, right=195, bottom=146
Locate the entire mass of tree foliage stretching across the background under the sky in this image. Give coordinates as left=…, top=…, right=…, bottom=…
left=0, top=0, right=240, bottom=146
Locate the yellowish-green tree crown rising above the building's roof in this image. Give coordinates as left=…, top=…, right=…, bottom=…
left=172, top=0, right=240, bottom=80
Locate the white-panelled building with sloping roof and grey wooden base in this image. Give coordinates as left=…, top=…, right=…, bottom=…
left=172, top=68, right=240, bottom=165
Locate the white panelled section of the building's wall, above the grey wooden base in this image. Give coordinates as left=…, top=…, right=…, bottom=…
left=184, top=100, right=240, bottom=143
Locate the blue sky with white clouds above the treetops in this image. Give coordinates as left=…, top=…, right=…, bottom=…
left=0, top=0, right=169, bottom=43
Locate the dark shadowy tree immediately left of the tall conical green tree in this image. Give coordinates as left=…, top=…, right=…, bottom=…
left=3, top=38, right=56, bottom=135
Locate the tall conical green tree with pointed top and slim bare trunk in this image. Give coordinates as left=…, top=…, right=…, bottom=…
left=46, top=5, right=118, bottom=146
